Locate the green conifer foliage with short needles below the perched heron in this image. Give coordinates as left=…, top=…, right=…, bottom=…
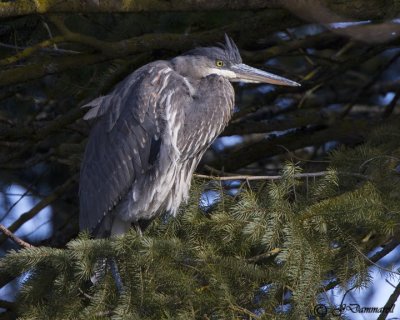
left=1, top=125, right=400, bottom=319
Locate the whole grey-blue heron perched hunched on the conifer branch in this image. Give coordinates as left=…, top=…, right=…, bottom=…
left=79, top=35, right=299, bottom=237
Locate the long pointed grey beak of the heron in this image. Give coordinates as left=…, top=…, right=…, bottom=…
left=230, top=63, right=301, bottom=87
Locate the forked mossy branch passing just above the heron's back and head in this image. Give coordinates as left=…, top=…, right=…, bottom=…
left=0, top=10, right=298, bottom=87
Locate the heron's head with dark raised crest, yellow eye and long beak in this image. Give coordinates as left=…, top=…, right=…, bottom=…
left=172, top=34, right=300, bottom=86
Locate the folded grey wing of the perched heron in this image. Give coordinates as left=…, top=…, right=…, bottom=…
left=79, top=62, right=188, bottom=232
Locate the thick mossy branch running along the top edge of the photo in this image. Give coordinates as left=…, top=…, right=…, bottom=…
left=0, top=0, right=399, bottom=22
